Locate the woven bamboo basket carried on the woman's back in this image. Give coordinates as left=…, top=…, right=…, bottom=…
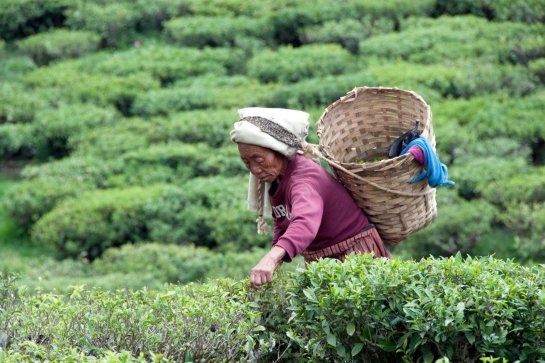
left=318, top=87, right=437, bottom=245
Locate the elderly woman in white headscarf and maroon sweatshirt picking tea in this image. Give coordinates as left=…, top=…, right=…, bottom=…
left=231, top=107, right=412, bottom=288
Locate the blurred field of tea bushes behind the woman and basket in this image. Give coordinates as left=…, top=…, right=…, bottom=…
left=0, top=0, right=545, bottom=291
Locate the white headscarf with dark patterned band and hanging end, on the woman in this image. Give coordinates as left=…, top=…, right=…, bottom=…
left=231, top=107, right=309, bottom=233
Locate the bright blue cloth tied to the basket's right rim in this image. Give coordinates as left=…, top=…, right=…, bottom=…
left=401, top=137, right=454, bottom=188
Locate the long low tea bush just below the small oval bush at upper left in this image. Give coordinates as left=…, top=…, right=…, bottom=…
left=23, top=64, right=160, bottom=114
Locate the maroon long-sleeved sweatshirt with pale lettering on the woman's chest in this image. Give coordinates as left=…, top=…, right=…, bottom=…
left=269, top=155, right=369, bottom=261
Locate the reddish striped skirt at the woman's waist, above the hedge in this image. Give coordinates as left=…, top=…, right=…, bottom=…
left=302, top=224, right=392, bottom=262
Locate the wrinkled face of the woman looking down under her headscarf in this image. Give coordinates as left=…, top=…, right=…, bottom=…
left=238, top=144, right=288, bottom=183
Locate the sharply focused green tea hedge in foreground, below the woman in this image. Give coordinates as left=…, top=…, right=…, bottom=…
left=0, top=255, right=545, bottom=362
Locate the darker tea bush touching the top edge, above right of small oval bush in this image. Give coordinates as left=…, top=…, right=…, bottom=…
left=65, top=2, right=139, bottom=46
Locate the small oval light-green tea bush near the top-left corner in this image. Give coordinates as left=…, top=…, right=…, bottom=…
left=17, top=29, right=100, bottom=65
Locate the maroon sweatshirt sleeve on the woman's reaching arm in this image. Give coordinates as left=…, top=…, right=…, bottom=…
left=276, top=183, right=324, bottom=262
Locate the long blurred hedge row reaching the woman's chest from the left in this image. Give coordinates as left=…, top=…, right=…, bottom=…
left=32, top=177, right=270, bottom=259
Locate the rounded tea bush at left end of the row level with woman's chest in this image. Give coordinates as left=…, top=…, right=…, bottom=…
left=32, top=186, right=168, bottom=259
